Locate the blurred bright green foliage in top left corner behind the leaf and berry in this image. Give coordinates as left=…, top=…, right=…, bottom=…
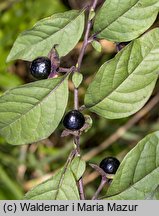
left=0, top=0, right=66, bottom=90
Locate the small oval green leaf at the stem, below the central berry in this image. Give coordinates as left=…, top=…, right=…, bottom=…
left=71, top=157, right=86, bottom=181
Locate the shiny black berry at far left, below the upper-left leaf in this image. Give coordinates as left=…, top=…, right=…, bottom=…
left=30, top=57, right=51, bottom=79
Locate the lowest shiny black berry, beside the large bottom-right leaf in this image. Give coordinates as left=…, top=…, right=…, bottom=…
left=99, top=157, right=120, bottom=174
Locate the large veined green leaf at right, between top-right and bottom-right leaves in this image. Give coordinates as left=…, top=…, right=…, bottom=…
left=85, top=28, right=159, bottom=119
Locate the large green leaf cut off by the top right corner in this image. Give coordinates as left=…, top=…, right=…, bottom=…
left=94, top=0, right=159, bottom=42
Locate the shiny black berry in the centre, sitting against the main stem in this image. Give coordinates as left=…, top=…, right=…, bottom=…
left=63, top=110, right=85, bottom=130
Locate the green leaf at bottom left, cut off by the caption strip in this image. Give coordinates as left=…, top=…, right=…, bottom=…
left=24, top=167, right=79, bottom=200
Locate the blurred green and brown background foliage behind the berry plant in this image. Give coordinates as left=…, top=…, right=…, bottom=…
left=0, top=0, right=159, bottom=200
